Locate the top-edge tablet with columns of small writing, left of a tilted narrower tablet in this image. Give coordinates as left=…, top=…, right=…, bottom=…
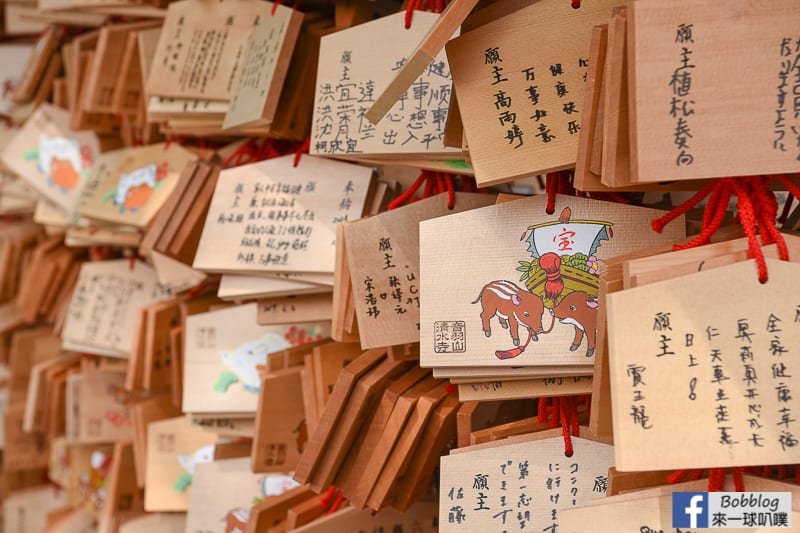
left=146, top=0, right=272, bottom=100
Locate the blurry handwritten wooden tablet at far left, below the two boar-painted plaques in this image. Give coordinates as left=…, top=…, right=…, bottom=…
left=62, top=259, right=172, bottom=357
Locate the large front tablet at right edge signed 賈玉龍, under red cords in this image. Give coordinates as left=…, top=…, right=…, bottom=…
left=608, top=259, right=800, bottom=470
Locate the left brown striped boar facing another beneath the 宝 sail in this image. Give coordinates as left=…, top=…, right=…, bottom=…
left=472, top=280, right=544, bottom=346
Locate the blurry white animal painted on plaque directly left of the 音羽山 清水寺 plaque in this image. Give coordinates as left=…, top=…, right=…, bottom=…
left=214, top=332, right=291, bottom=392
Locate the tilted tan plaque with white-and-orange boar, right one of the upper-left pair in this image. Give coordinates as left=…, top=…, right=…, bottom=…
left=80, top=143, right=197, bottom=228
